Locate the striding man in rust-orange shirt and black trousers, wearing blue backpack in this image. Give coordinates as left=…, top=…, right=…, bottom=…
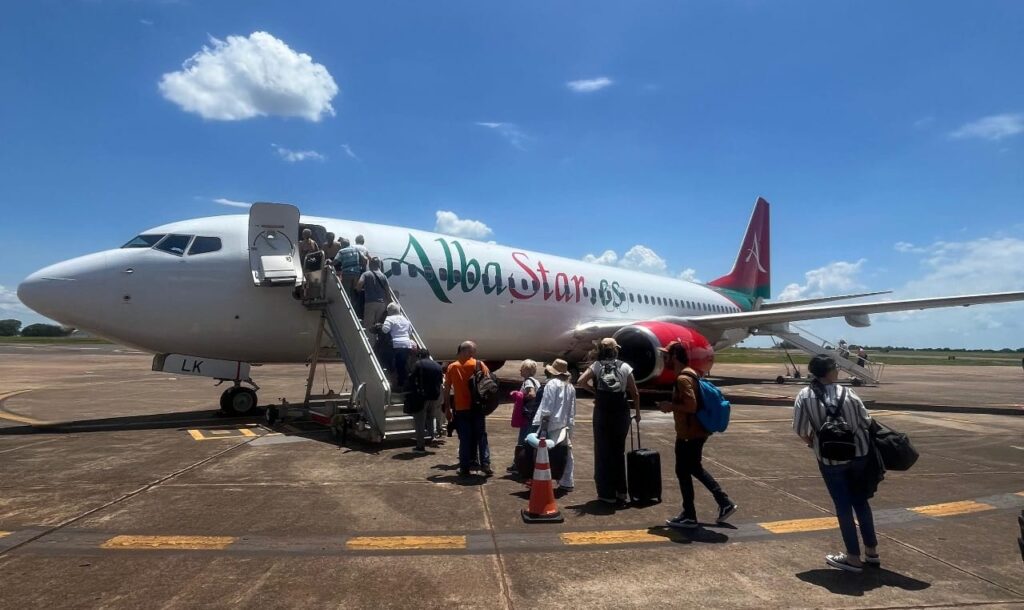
left=658, top=341, right=739, bottom=529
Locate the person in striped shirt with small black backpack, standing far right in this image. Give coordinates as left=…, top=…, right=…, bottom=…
left=793, top=354, right=880, bottom=573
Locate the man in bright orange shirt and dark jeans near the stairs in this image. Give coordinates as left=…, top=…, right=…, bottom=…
left=441, top=341, right=497, bottom=477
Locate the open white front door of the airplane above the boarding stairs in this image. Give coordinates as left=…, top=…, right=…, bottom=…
left=248, top=203, right=302, bottom=287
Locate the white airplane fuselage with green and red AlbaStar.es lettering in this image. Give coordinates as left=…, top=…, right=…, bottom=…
left=18, top=215, right=746, bottom=362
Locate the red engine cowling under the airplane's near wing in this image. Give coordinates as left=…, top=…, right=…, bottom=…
left=614, top=321, right=715, bottom=385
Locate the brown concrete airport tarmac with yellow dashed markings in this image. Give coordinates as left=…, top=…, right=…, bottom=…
left=0, top=345, right=1024, bottom=608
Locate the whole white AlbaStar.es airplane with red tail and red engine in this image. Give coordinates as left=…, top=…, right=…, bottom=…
left=17, top=198, right=1024, bottom=415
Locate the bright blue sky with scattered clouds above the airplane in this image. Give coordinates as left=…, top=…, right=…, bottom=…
left=0, top=0, right=1024, bottom=348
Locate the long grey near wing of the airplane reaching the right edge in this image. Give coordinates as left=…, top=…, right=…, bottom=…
left=671, top=292, right=1024, bottom=330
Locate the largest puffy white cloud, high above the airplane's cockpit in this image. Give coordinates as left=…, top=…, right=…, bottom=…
left=160, top=32, right=338, bottom=122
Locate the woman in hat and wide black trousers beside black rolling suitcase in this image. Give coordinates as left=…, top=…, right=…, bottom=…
left=580, top=337, right=640, bottom=505
